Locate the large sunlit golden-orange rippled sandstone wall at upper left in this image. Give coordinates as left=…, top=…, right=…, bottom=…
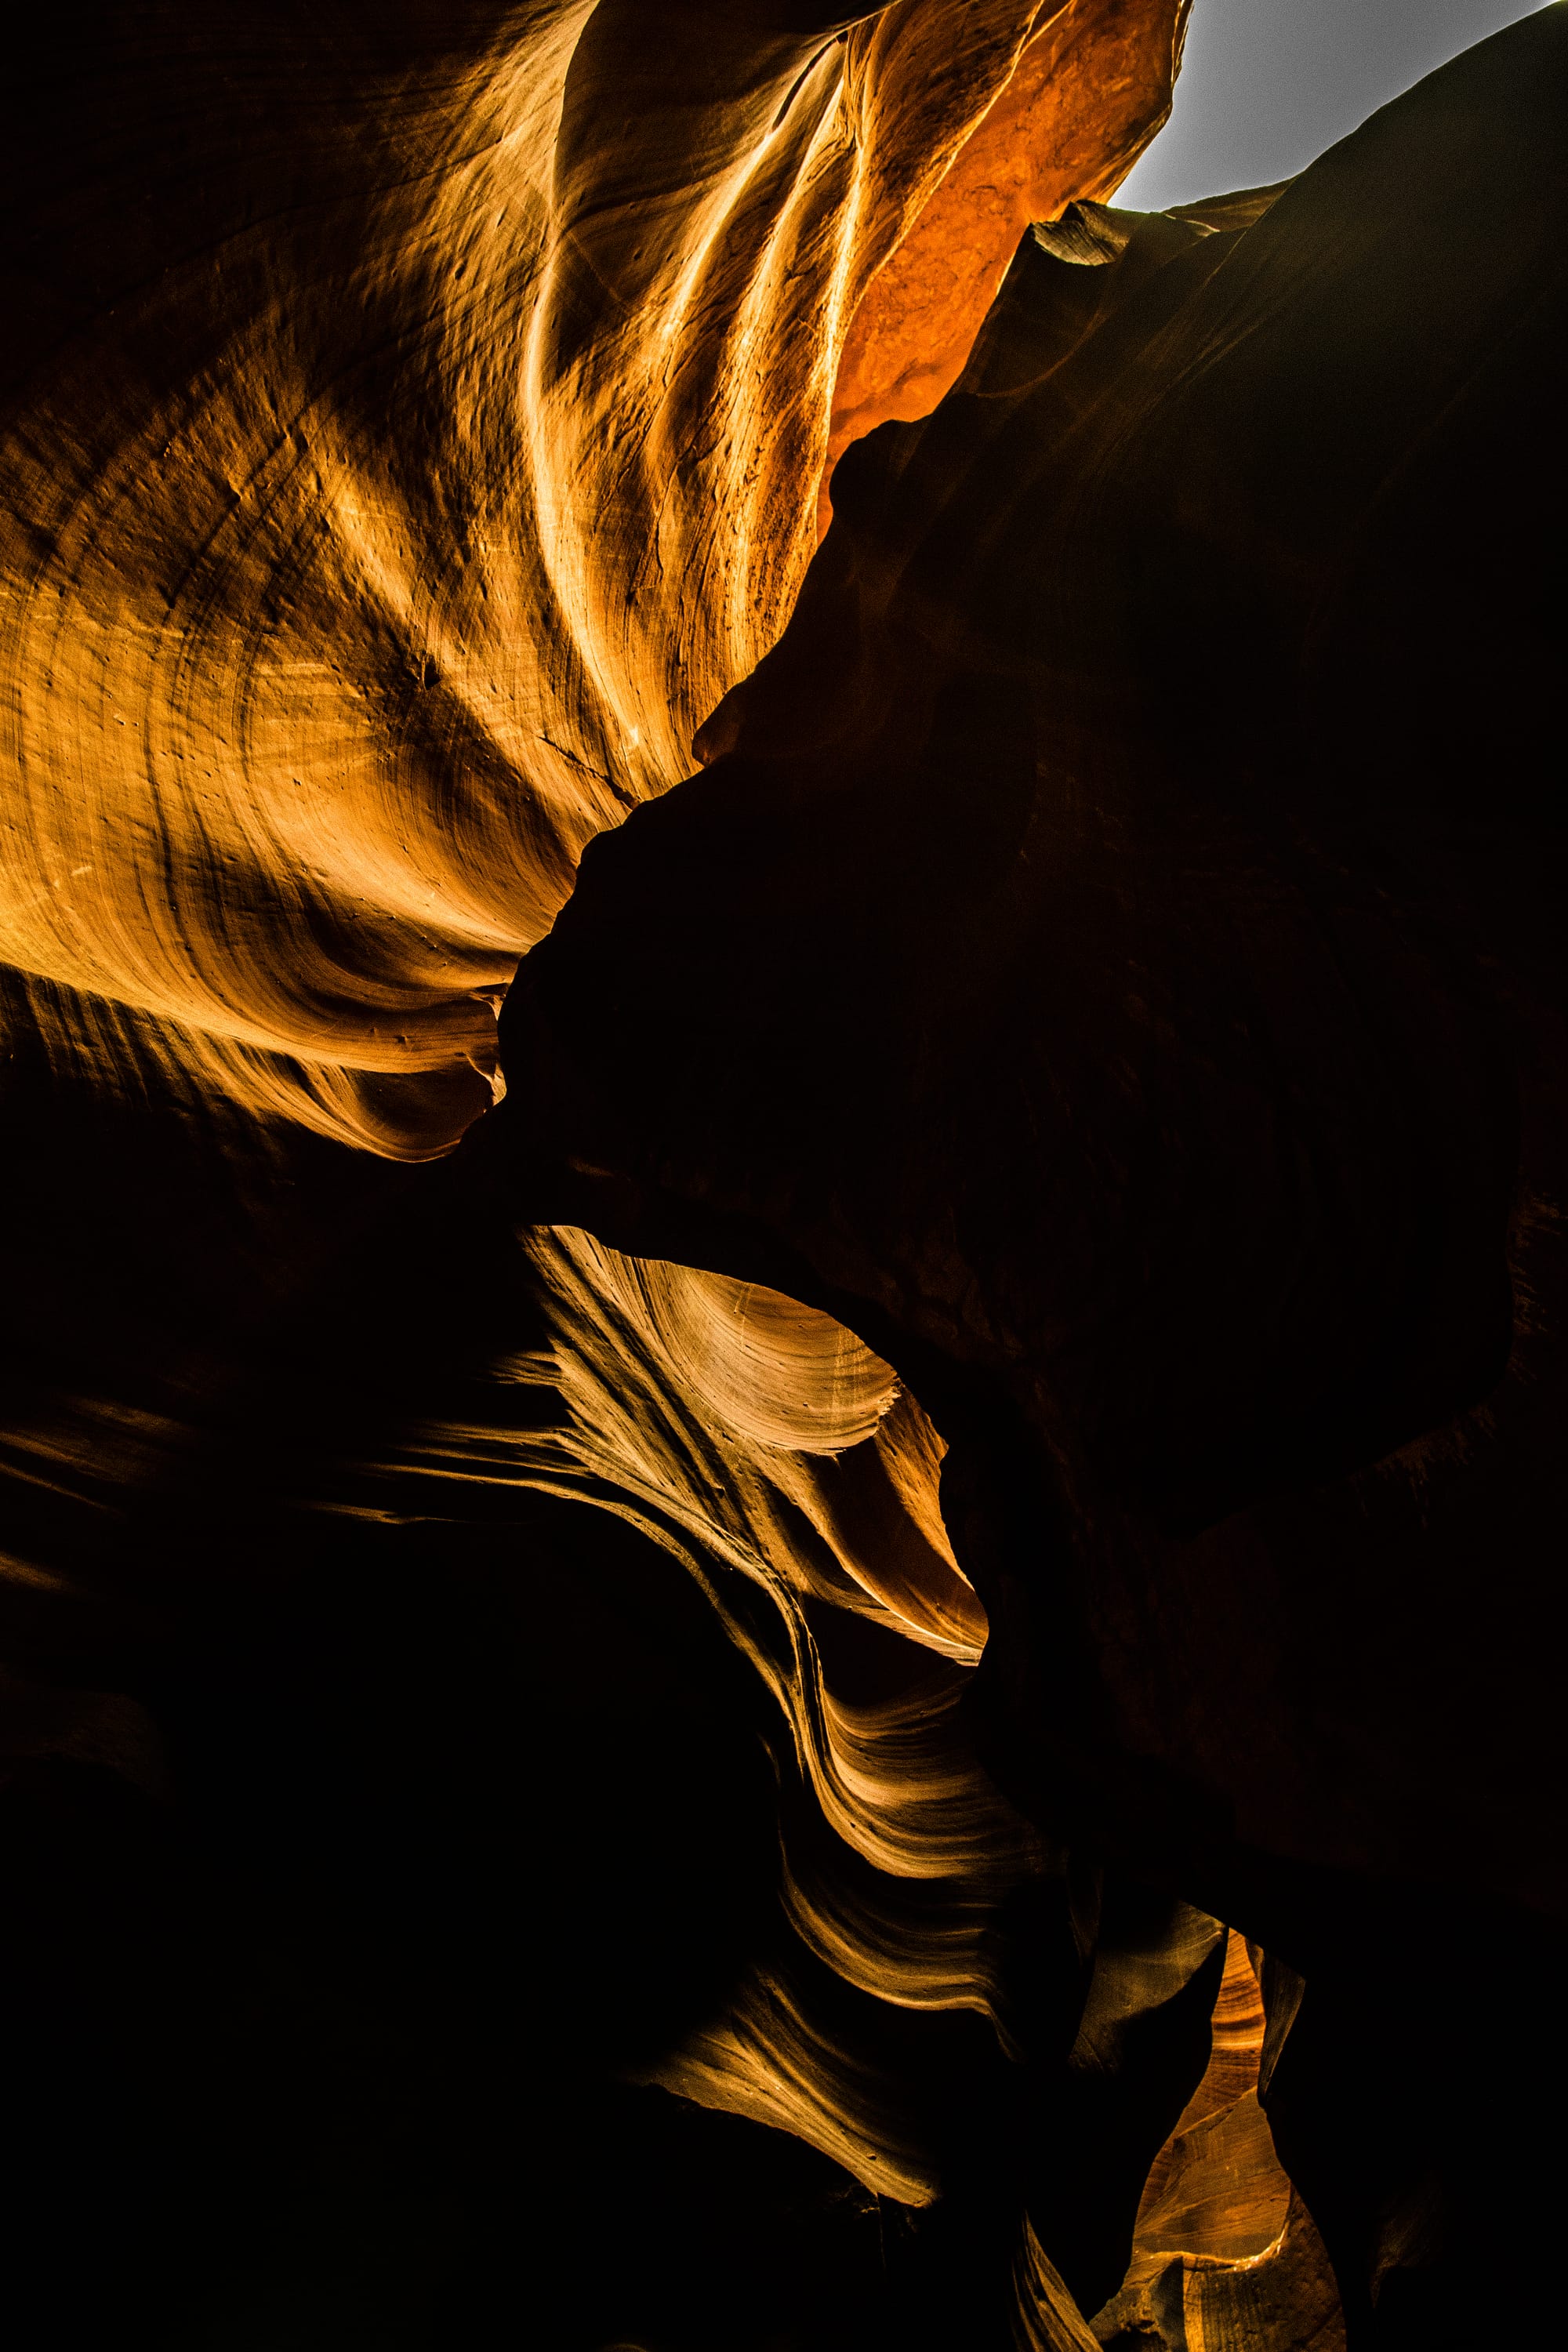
left=0, top=0, right=1180, bottom=1155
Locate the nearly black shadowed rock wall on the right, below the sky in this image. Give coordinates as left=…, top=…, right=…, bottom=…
left=501, top=12, right=1568, bottom=2340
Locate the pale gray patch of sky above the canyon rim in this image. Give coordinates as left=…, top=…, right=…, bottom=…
left=1112, top=0, right=1568, bottom=212
